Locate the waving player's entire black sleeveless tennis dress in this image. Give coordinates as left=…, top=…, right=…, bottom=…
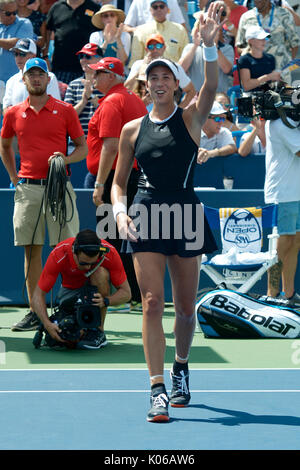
left=122, top=108, right=217, bottom=257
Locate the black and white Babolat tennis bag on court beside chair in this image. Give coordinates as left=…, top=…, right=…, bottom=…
left=195, top=289, right=300, bottom=339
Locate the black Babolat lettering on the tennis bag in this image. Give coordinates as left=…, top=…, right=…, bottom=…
left=210, top=294, right=296, bottom=336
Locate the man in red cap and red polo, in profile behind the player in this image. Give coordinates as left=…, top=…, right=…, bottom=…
left=87, top=57, right=147, bottom=302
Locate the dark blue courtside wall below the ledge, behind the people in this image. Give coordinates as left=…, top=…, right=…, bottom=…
left=0, top=189, right=300, bottom=305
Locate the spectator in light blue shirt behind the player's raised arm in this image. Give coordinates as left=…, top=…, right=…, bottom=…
left=179, top=10, right=234, bottom=92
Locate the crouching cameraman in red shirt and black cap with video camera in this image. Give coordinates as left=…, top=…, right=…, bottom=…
left=33, top=229, right=131, bottom=349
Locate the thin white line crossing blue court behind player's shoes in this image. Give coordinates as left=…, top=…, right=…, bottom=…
left=0, top=389, right=300, bottom=394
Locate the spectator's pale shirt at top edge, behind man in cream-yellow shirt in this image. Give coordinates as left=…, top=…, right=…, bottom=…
left=124, top=0, right=185, bottom=33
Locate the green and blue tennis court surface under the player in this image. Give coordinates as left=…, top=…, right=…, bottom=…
left=0, top=307, right=300, bottom=451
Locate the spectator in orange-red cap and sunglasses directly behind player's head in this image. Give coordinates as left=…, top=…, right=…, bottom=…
left=125, top=34, right=196, bottom=108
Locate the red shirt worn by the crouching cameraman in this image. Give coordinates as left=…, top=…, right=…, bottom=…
left=38, top=237, right=127, bottom=292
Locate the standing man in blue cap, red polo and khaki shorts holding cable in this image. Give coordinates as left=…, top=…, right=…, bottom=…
left=0, top=58, right=87, bottom=331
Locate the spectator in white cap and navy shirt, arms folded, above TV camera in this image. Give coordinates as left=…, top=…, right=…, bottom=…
left=237, top=26, right=281, bottom=91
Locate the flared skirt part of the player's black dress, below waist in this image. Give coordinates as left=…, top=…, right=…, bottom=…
left=122, top=188, right=217, bottom=258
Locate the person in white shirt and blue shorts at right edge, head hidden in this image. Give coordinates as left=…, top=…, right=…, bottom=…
left=264, top=97, right=300, bottom=306
